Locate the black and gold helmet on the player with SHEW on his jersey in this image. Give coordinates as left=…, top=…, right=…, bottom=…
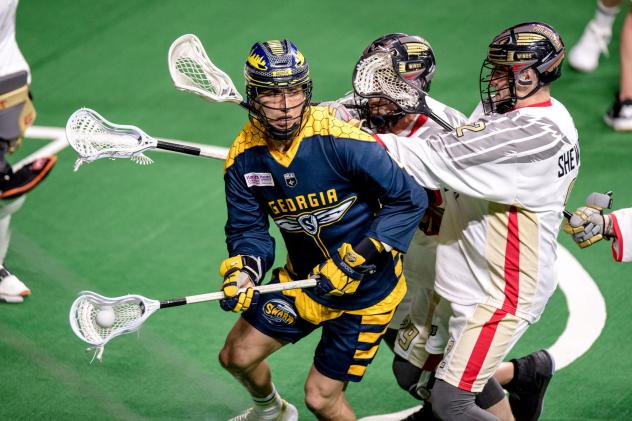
left=480, top=22, right=566, bottom=114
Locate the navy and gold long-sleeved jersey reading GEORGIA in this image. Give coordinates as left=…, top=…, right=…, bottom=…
left=224, top=107, right=427, bottom=309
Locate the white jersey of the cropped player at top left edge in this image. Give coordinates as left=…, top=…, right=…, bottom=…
left=0, top=0, right=31, bottom=80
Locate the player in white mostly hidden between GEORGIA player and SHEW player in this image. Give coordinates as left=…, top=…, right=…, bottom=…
left=327, top=33, right=467, bottom=419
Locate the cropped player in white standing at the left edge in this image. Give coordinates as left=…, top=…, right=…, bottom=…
left=0, top=0, right=57, bottom=303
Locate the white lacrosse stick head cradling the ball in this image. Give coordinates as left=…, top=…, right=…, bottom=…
left=69, top=291, right=160, bottom=360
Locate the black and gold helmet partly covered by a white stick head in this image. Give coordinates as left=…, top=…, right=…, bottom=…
left=356, top=33, right=436, bottom=132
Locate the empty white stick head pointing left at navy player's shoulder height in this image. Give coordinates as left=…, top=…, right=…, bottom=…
left=66, top=108, right=158, bottom=171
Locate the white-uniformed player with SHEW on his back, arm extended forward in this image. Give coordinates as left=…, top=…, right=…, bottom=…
left=362, top=22, right=579, bottom=420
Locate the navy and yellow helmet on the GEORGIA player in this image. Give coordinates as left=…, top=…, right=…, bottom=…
left=244, top=40, right=312, bottom=140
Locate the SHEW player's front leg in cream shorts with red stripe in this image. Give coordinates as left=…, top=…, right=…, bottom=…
left=432, top=303, right=528, bottom=421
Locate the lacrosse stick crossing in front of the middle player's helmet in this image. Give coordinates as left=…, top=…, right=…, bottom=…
left=353, top=51, right=454, bottom=131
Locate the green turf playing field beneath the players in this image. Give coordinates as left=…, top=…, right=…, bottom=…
left=0, top=0, right=632, bottom=420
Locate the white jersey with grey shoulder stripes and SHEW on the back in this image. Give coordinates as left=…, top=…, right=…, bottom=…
left=379, top=99, right=579, bottom=322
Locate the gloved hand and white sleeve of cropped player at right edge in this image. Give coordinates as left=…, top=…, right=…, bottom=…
left=564, top=192, right=632, bottom=262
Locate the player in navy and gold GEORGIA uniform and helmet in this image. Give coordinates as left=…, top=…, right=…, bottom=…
left=219, top=40, right=427, bottom=420
